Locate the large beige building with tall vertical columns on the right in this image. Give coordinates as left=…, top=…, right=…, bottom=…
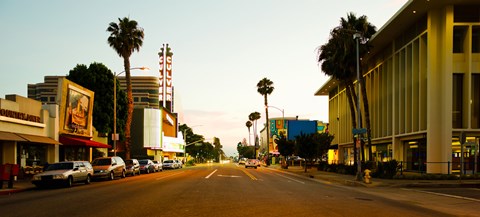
left=315, top=0, right=480, bottom=174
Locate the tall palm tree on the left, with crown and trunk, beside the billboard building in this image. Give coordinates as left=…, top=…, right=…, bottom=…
left=107, top=17, right=144, bottom=159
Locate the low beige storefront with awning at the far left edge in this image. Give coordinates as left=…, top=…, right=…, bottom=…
left=0, top=95, right=60, bottom=175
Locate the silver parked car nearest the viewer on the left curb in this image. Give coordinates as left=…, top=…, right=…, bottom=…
left=32, top=161, right=93, bottom=187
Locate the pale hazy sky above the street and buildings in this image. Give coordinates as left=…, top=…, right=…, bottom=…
left=0, top=0, right=407, bottom=156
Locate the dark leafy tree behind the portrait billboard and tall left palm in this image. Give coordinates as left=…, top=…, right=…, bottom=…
left=66, top=63, right=127, bottom=140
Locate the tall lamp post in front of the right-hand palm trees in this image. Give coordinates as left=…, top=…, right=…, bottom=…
left=353, top=32, right=363, bottom=181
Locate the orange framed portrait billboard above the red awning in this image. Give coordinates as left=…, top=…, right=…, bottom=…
left=57, top=78, right=94, bottom=137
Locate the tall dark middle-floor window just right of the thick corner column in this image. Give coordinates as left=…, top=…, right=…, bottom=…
left=452, top=73, right=463, bottom=128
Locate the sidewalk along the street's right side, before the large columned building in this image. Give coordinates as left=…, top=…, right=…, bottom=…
left=267, top=164, right=480, bottom=188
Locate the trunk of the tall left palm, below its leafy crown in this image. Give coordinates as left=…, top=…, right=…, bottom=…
left=123, top=57, right=133, bottom=160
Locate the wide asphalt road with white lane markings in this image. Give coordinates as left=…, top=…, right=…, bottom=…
left=0, top=164, right=479, bottom=217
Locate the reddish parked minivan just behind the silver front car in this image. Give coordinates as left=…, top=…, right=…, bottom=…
left=92, top=156, right=126, bottom=180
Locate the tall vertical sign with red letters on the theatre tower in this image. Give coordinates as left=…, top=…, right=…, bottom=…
left=158, top=44, right=173, bottom=110
